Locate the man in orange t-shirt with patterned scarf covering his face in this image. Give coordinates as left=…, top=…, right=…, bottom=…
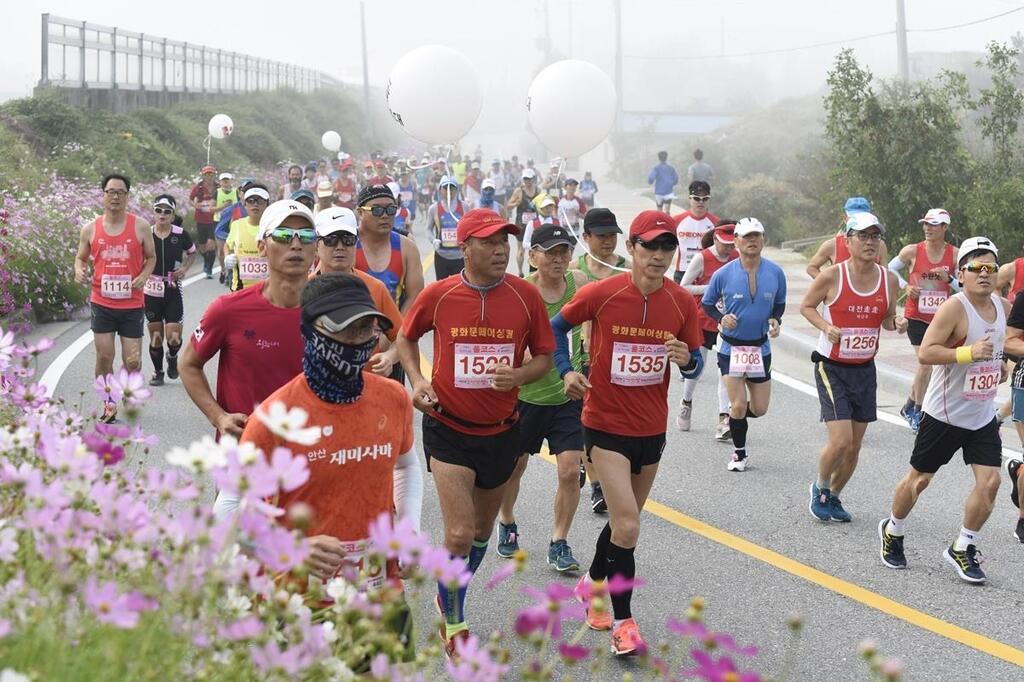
left=214, top=272, right=423, bottom=659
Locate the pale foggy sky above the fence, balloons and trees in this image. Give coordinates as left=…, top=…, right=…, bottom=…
left=0, top=0, right=1024, bottom=151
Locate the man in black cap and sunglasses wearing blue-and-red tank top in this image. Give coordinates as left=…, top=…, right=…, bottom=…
left=355, top=184, right=423, bottom=315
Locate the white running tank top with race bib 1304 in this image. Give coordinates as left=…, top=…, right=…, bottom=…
left=923, top=292, right=1007, bottom=431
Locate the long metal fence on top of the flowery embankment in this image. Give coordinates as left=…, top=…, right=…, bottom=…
left=39, top=13, right=340, bottom=93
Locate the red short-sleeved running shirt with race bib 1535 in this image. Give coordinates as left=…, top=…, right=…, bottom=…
left=561, top=272, right=703, bottom=436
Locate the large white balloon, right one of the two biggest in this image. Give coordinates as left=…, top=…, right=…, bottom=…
left=526, top=59, right=616, bottom=157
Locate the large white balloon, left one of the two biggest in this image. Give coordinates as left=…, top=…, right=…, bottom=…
left=387, top=45, right=483, bottom=144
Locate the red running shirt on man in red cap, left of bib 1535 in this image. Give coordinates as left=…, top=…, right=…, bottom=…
left=401, top=274, right=555, bottom=435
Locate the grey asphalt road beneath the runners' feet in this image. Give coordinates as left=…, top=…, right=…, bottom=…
left=32, top=220, right=1024, bottom=680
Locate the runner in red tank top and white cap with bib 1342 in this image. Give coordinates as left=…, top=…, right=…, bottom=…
left=889, top=209, right=956, bottom=433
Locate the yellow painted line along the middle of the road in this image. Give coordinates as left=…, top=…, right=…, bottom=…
left=409, top=252, right=1024, bottom=667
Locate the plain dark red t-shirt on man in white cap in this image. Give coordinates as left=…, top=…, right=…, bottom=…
left=191, top=282, right=304, bottom=415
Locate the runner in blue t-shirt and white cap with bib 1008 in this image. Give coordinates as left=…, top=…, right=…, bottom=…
left=701, top=218, right=786, bottom=471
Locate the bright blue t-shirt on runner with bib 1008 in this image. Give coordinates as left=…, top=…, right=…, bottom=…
left=700, top=258, right=785, bottom=355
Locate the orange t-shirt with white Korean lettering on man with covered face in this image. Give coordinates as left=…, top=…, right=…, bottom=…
left=242, top=373, right=413, bottom=587
